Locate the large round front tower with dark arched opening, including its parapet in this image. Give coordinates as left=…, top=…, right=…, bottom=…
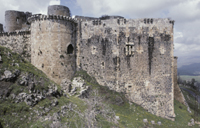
left=29, top=15, right=76, bottom=84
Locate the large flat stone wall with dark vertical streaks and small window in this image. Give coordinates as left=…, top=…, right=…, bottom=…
left=77, top=18, right=175, bottom=119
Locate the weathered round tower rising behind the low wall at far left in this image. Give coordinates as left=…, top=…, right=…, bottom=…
left=5, top=10, right=26, bottom=32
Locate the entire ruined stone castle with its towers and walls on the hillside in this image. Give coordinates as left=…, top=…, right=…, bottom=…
left=0, top=5, right=184, bottom=120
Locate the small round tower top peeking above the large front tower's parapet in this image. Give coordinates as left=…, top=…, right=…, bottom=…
left=48, top=5, right=70, bottom=16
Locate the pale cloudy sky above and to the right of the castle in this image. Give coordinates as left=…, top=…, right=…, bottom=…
left=0, top=0, right=200, bottom=66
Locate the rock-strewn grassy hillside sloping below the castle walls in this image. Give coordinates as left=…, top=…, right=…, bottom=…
left=0, top=47, right=199, bottom=128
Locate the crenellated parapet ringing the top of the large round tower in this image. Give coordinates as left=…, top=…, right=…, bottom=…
left=28, top=14, right=78, bottom=23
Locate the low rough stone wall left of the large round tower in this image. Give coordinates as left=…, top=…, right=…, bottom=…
left=0, top=31, right=31, bottom=62
